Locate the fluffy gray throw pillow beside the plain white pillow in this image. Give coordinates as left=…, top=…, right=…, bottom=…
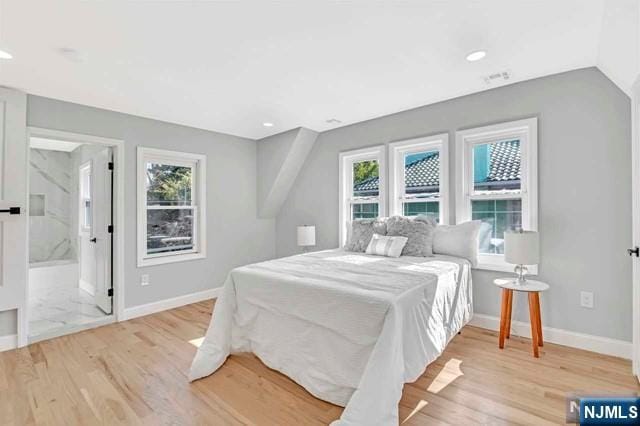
left=387, top=216, right=435, bottom=257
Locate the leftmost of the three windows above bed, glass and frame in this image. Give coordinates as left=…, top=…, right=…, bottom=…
left=339, top=146, right=386, bottom=245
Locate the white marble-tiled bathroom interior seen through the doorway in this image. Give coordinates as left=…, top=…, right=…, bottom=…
left=28, top=137, right=112, bottom=342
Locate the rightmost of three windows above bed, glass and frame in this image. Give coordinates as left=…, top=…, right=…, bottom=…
left=456, top=118, right=538, bottom=273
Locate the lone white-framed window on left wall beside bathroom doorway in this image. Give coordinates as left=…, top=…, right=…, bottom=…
left=138, top=147, right=206, bottom=266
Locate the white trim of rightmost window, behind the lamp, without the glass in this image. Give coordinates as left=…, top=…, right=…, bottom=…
left=456, top=117, right=538, bottom=275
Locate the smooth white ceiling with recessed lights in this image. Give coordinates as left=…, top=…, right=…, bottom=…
left=0, top=0, right=637, bottom=138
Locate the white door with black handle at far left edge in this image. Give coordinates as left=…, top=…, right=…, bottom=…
left=0, top=87, right=28, bottom=346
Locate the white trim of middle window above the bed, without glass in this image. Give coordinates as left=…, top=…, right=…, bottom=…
left=389, top=133, right=449, bottom=225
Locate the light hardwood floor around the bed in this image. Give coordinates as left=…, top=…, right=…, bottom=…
left=0, top=302, right=640, bottom=425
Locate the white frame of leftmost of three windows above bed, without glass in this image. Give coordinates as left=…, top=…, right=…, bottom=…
left=338, top=145, right=387, bottom=247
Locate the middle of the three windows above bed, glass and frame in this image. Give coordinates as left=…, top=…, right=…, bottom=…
left=389, top=134, right=449, bottom=223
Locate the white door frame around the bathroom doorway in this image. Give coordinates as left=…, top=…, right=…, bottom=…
left=18, top=126, right=125, bottom=347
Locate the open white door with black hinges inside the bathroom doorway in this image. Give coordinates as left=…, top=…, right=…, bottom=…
left=91, top=148, right=113, bottom=314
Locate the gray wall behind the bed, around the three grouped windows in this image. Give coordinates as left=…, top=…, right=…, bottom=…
left=276, top=68, right=632, bottom=341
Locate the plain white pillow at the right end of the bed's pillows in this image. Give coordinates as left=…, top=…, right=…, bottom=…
left=433, top=220, right=482, bottom=266
